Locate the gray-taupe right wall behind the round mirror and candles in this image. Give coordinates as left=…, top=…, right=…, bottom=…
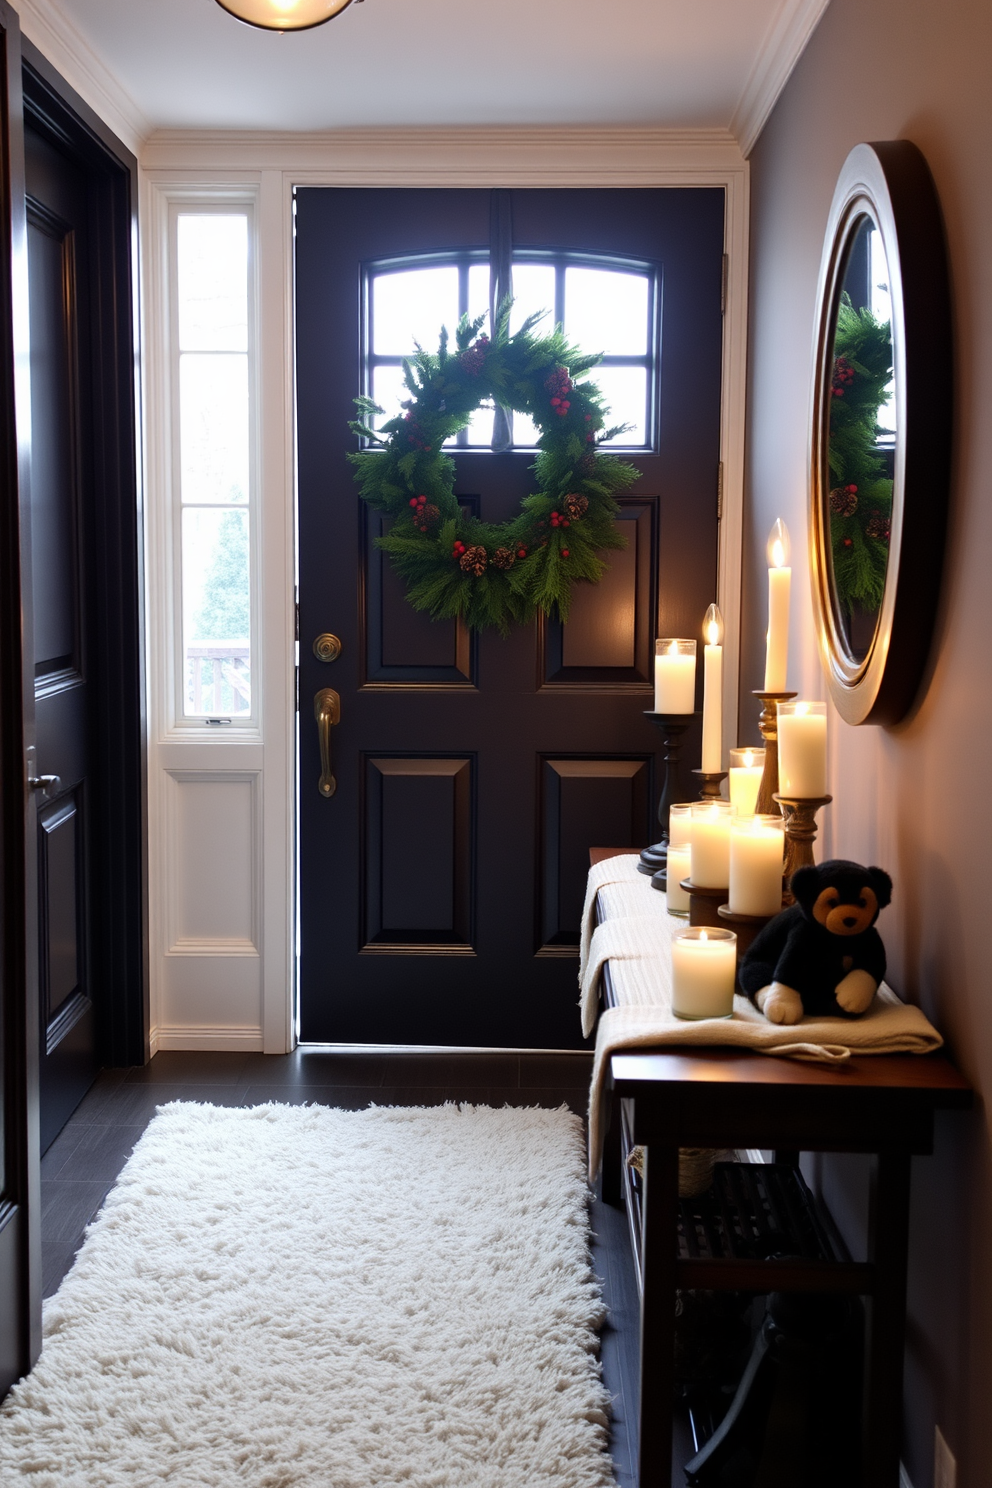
left=741, top=0, right=992, bottom=1488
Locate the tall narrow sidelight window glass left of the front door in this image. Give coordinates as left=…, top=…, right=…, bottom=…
left=173, top=210, right=253, bottom=720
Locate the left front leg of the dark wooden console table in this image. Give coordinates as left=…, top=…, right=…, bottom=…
left=638, top=1143, right=678, bottom=1488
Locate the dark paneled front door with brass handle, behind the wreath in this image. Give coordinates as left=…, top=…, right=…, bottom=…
left=296, top=187, right=724, bottom=1048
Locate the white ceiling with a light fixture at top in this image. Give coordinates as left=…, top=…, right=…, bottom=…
left=23, top=0, right=825, bottom=135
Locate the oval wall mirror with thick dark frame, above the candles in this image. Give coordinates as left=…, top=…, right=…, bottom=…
left=809, top=140, right=952, bottom=725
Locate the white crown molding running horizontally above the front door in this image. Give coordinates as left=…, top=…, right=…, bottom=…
left=140, top=125, right=745, bottom=176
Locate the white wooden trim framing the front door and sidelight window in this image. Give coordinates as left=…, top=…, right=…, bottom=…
left=141, top=128, right=748, bottom=1054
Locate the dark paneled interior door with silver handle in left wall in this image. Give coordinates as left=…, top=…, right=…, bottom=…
left=25, top=128, right=98, bottom=1150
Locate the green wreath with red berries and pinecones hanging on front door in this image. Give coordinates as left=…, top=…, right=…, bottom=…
left=348, top=304, right=638, bottom=634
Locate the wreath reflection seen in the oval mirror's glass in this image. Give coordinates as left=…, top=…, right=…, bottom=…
left=830, top=293, right=892, bottom=615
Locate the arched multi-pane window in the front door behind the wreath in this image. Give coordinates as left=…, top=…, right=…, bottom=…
left=364, top=251, right=659, bottom=449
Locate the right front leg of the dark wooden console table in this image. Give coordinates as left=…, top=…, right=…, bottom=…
left=861, top=1152, right=912, bottom=1488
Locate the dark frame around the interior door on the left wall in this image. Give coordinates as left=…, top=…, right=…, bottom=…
left=22, top=39, right=149, bottom=1065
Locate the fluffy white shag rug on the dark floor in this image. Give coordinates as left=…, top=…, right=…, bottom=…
left=0, top=1103, right=614, bottom=1488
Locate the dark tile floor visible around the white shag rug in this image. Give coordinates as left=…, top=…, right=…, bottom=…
left=42, top=1049, right=638, bottom=1488
